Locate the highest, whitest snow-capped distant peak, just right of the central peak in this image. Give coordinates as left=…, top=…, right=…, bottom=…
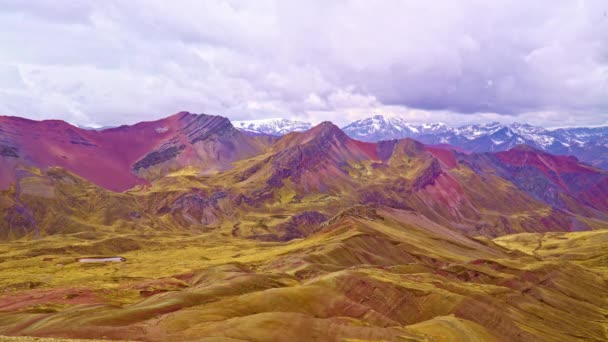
left=342, top=115, right=448, bottom=141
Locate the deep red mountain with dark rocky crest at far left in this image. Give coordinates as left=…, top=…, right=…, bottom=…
left=0, top=112, right=262, bottom=191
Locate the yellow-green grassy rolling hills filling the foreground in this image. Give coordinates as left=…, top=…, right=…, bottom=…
left=0, top=207, right=608, bottom=341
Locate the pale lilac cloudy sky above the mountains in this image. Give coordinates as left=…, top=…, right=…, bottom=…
left=0, top=0, right=608, bottom=127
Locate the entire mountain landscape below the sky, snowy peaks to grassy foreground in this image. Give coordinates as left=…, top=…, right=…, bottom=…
left=0, top=112, right=608, bottom=341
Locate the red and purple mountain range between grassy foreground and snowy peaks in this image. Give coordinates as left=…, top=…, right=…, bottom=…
left=0, top=112, right=608, bottom=239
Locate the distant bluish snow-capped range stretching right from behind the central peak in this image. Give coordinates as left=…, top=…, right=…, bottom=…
left=343, top=115, right=608, bottom=169
